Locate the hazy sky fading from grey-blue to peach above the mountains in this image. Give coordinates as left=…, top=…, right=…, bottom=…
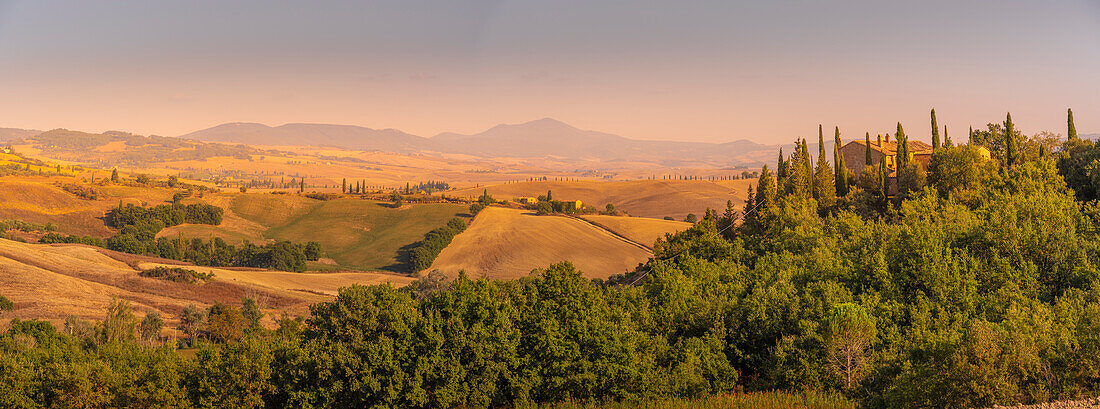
left=0, top=0, right=1100, bottom=143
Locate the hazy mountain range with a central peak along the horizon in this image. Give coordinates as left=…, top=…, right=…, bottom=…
left=180, top=118, right=779, bottom=166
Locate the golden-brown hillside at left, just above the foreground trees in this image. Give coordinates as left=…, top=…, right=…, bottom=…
left=0, top=239, right=410, bottom=323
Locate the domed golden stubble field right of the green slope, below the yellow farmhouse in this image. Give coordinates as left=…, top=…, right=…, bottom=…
left=429, top=207, right=651, bottom=279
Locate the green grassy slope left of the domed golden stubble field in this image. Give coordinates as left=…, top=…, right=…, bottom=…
left=231, top=195, right=465, bottom=272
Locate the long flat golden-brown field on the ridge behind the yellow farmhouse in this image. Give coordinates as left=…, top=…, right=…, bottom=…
left=447, top=179, right=756, bottom=220
